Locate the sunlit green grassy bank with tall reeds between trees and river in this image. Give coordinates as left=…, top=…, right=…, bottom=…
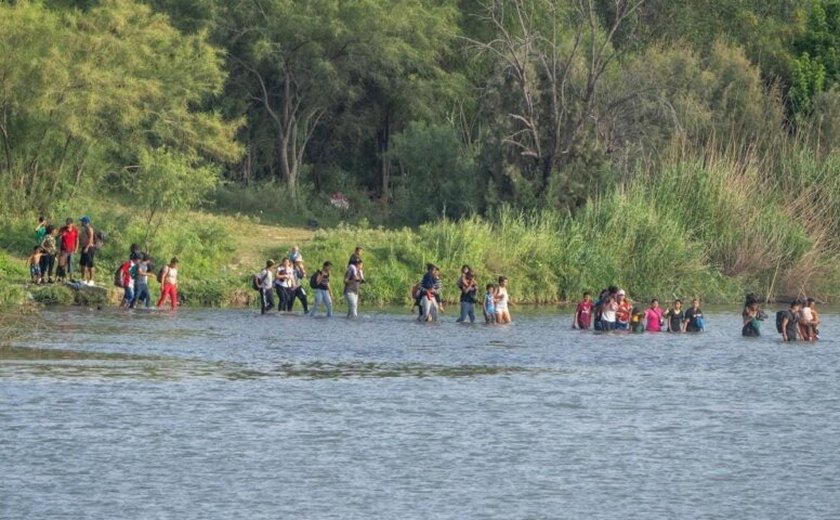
left=0, top=145, right=840, bottom=306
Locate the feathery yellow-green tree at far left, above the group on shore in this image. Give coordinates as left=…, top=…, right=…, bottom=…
left=0, top=0, right=240, bottom=208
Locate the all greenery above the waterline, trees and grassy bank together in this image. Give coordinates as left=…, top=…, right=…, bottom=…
left=0, top=0, right=840, bottom=307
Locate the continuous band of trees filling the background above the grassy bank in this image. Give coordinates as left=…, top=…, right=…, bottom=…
left=0, top=0, right=840, bottom=224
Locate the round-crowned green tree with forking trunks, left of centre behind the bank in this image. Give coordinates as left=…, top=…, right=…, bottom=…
left=212, top=0, right=457, bottom=202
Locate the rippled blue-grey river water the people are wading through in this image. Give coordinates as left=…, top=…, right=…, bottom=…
left=0, top=309, right=840, bottom=519
